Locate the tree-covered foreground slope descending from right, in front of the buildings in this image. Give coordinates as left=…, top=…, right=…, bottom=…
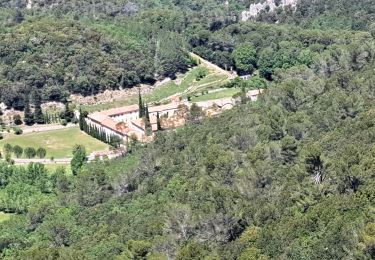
left=0, top=23, right=375, bottom=259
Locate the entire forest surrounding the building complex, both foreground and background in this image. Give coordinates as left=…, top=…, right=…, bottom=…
left=0, top=0, right=375, bottom=260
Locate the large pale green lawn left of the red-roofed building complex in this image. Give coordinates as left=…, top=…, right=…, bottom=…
left=0, top=127, right=108, bottom=158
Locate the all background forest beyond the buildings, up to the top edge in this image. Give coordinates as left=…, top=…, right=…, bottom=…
left=0, top=0, right=375, bottom=107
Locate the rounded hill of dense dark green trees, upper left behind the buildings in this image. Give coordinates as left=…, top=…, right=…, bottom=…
left=0, top=17, right=188, bottom=108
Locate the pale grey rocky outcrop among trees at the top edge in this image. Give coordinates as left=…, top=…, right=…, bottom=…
left=241, top=0, right=298, bottom=21
